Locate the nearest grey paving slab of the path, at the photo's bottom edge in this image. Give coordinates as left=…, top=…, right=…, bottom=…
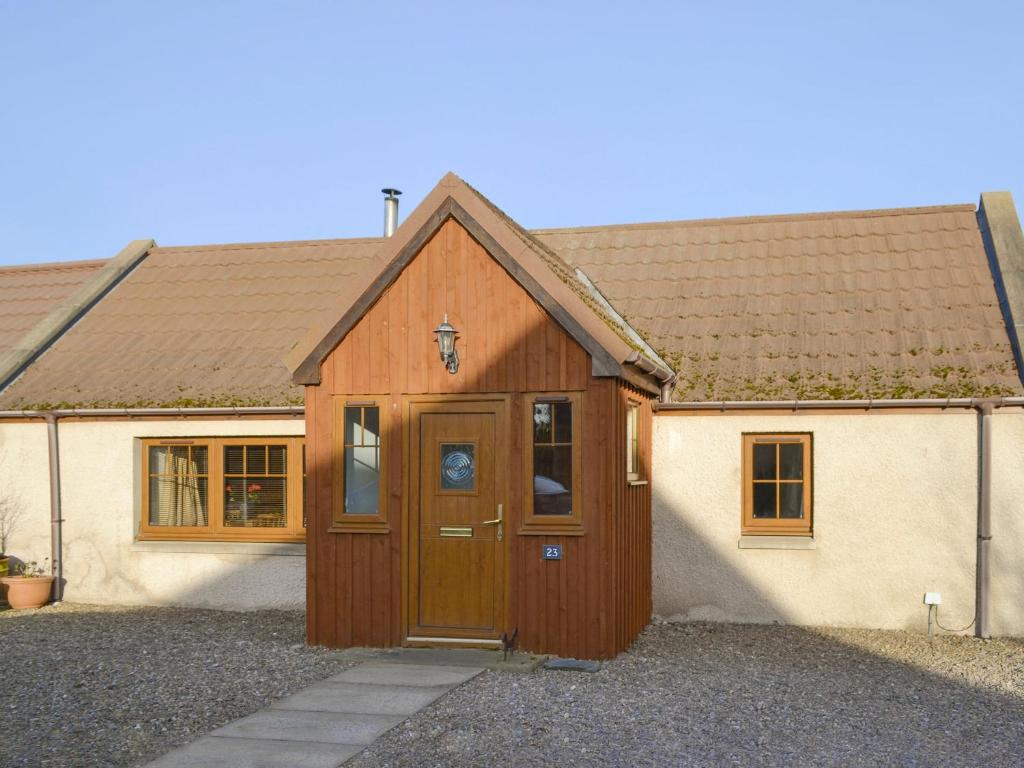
left=142, top=736, right=362, bottom=768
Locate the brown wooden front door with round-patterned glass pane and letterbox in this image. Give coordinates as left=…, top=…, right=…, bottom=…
left=409, top=400, right=508, bottom=642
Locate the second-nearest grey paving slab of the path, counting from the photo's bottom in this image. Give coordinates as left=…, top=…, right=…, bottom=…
left=210, top=710, right=406, bottom=744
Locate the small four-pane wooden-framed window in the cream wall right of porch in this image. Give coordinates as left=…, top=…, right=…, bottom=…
left=742, top=433, right=812, bottom=536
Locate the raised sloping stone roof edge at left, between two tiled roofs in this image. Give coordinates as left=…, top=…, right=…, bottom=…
left=0, top=240, right=156, bottom=392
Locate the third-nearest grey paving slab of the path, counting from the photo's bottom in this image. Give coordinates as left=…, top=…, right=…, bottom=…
left=270, top=681, right=451, bottom=717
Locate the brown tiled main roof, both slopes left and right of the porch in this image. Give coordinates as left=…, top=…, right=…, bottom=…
left=0, top=198, right=1022, bottom=409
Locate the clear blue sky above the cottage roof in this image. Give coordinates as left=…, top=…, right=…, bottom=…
left=0, top=0, right=1024, bottom=264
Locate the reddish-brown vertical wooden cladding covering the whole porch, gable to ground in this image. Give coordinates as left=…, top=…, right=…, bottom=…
left=306, top=220, right=651, bottom=658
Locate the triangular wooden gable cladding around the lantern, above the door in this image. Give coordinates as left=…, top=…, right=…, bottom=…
left=321, top=220, right=590, bottom=394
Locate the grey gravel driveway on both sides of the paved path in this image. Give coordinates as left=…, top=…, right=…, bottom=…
left=0, top=604, right=1024, bottom=768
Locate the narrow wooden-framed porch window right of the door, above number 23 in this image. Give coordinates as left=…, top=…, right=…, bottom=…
left=521, top=392, right=583, bottom=535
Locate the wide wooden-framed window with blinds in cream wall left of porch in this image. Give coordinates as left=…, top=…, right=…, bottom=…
left=138, top=437, right=306, bottom=542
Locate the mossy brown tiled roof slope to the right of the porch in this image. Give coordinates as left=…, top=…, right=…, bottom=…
left=534, top=205, right=1022, bottom=400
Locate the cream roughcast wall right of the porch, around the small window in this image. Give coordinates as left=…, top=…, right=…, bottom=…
left=652, top=411, right=1011, bottom=634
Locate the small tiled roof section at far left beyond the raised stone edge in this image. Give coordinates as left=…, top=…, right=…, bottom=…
left=0, top=259, right=105, bottom=355
